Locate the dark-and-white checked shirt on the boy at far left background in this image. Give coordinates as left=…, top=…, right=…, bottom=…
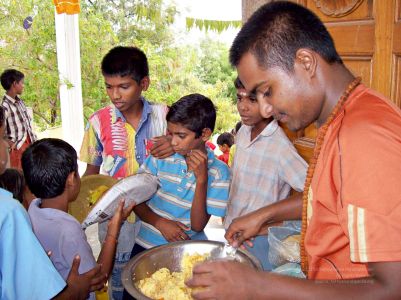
left=1, top=94, right=37, bottom=150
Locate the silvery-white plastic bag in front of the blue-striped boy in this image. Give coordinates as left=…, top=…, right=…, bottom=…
left=82, top=173, right=158, bottom=229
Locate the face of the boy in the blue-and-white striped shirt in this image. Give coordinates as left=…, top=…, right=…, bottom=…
left=167, top=122, right=205, bottom=156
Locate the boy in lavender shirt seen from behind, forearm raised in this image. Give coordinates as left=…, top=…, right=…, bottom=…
left=22, top=139, right=133, bottom=299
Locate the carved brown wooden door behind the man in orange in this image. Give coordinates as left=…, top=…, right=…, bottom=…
left=242, top=0, right=401, bottom=161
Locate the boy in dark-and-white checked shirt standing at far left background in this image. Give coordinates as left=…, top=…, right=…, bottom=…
left=0, top=69, right=37, bottom=169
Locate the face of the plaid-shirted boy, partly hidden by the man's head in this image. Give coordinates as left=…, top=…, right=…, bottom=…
left=237, top=89, right=264, bottom=126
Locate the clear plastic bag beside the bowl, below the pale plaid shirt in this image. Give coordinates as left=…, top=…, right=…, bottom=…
left=267, top=226, right=301, bottom=267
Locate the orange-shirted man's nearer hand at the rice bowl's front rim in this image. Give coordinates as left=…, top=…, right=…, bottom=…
left=186, top=261, right=257, bottom=300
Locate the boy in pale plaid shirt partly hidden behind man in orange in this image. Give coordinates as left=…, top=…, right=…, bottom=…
left=224, top=78, right=307, bottom=271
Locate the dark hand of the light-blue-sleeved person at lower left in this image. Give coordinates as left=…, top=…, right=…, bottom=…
left=56, top=256, right=107, bottom=300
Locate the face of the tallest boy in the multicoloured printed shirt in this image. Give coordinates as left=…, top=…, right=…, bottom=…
left=104, top=76, right=149, bottom=113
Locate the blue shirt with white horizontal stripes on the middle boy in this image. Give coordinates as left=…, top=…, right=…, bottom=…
left=136, top=149, right=230, bottom=248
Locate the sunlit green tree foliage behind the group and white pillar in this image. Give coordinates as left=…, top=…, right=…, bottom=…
left=0, top=0, right=238, bottom=132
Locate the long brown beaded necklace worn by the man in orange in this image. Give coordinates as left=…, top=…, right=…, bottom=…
left=300, top=77, right=361, bottom=275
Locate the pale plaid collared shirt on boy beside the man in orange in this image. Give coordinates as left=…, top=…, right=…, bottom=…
left=224, top=120, right=307, bottom=228
